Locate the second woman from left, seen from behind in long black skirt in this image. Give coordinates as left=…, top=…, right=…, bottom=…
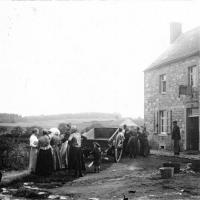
left=36, top=130, right=54, bottom=176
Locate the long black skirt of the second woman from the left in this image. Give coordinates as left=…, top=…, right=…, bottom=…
left=36, top=149, right=54, bottom=176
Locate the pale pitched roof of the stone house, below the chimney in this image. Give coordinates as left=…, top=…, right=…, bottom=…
left=145, top=27, right=200, bottom=71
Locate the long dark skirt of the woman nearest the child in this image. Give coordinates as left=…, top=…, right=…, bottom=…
left=68, top=146, right=85, bottom=172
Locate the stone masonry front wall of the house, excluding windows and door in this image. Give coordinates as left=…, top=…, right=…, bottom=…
left=144, top=56, right=199, bottom=150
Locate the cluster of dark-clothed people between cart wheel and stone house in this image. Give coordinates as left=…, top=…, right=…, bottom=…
left=123, top=125, right=150, bottom=158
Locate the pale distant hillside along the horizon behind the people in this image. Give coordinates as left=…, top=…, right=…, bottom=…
left=0, top=113, right=143, bottom=130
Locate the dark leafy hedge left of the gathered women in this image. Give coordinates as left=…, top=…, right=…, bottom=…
left=0, top=127, right=41, bottom=170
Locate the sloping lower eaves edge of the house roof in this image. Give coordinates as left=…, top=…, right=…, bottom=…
left=143, top=50, right=200, bottom=72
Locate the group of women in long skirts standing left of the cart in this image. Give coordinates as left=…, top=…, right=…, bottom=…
left=29, top=125, right=85, bottom=176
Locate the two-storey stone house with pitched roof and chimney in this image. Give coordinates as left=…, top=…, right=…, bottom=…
left=144, top=23, right=200, bottom=151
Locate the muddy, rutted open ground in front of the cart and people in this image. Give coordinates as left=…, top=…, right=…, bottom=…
left=1, top=156, right=200, bottom=200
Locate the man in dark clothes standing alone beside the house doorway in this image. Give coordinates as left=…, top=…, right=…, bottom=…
left=172, top=121, right=181, bottom=155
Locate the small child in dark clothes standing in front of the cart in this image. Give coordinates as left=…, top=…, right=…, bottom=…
left=92, top=142, right=101, bottom=173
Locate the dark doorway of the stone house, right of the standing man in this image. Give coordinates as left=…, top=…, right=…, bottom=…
left=187, top=116, right=199, bottom=151
